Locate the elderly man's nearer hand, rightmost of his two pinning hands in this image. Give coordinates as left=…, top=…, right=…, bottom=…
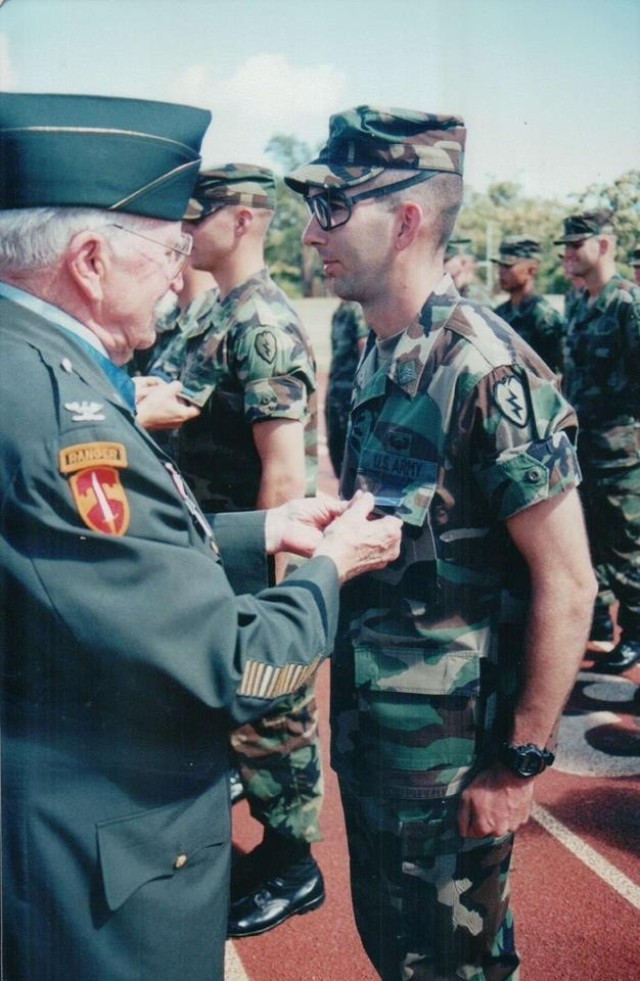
left=314, top=493, right=402, bottom=582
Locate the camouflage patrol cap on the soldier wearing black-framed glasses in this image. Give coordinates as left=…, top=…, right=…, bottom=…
left=285, top=106, right=466, bottom=194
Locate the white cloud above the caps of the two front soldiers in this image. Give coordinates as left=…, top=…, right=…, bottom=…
left=172, top=54, right=346, bottom=166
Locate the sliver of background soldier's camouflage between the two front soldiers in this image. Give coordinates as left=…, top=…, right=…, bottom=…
left=325, top=300, right=369, bottom=477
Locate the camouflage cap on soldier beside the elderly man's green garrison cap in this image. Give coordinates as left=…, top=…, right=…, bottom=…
left=184, top=164, right=276, bottom=221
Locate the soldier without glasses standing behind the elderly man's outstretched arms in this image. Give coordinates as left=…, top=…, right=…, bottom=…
left=175, top=164, right=324, bottom=937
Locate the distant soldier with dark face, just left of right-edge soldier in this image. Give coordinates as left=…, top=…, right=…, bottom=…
left=491, top=235, right=564, bottom=374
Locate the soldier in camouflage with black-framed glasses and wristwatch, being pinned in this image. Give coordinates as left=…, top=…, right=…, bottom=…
left=285, top=106, right=595, bottom=981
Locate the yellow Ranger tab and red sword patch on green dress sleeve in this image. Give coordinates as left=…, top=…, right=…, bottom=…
left=60, top=443, right=131, bottom=535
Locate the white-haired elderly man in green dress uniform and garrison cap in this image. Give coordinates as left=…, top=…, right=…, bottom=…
left=0, top=93, right=398, bottom=981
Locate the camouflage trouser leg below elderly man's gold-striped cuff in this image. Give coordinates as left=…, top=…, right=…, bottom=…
left=231, top=685, right=324, bottom=842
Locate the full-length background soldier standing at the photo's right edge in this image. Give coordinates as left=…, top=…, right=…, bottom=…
left=556, top=210, right=640, bottom=673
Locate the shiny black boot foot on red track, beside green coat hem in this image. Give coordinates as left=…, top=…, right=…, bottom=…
left=227, top=858, right=324, bottom=937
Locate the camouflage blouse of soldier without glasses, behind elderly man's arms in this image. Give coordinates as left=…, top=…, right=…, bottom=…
left=178, top=269, right=317, bottom=512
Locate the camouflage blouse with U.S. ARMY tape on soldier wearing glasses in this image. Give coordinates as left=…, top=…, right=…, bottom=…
left=332, top=276, right=579, bottom=799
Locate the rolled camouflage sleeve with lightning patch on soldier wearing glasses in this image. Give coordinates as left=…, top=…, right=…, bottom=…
left=463, top=365, right=581, bottom=521
